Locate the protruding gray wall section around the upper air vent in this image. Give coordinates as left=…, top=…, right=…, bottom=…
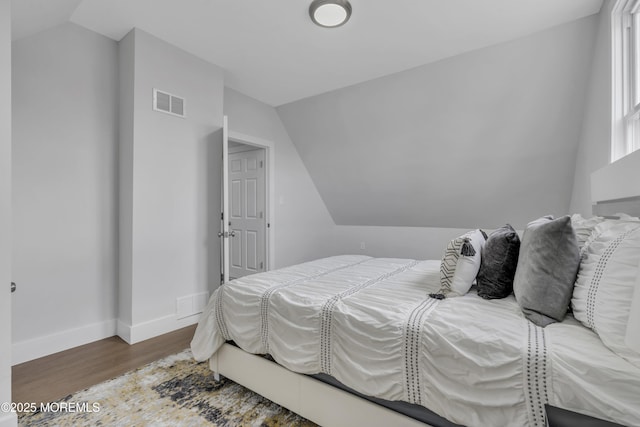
left=118, top=29, right=223, bottom=342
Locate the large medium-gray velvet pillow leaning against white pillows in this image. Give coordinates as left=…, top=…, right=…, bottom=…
left=513, top=215, right=580, bottom=327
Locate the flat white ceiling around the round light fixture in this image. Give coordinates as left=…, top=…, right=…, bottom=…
left=12, top=0, right=602, bottom=106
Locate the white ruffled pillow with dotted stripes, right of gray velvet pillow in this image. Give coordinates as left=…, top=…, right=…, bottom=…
left=571, top=221, right=640, bottom=367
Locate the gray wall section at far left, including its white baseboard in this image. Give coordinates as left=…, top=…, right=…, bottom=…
left=11, top=24, right=118, bottom=362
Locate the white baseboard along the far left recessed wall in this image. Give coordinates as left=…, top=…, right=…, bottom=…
left=11, top=319, right=116, bottom=365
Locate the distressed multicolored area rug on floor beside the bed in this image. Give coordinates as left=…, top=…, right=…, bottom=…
left=18, top=350, right=315, bottom=427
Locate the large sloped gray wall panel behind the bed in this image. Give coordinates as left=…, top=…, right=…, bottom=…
left=277, top=16, right=597, bottom=228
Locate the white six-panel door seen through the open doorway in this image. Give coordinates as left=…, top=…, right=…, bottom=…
left=228, top=149, right=266, bottom=279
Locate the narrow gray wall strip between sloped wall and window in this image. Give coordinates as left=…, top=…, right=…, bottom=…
left=570, top=0, right=614, bottom=215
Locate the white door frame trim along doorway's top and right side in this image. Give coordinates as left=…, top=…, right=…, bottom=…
left=229, top=130, right=276, bottom=270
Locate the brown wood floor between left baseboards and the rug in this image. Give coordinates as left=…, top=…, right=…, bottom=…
left=12, top=325, right=196, bottom=404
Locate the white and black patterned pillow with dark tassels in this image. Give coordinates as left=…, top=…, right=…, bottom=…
left=429, top=229, right=487, bottom=299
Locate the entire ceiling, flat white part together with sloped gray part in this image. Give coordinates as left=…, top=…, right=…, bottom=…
left=12, top=0, right=602, bottom=231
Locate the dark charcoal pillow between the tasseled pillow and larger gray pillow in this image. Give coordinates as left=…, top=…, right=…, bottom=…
left=476, top=224, right=520, bottom=299
